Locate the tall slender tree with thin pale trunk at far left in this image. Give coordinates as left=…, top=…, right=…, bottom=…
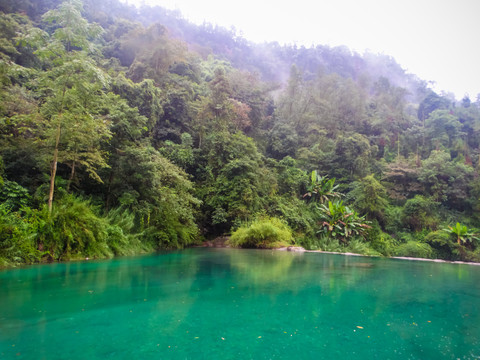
left=28, top=0, right=109, bottom=212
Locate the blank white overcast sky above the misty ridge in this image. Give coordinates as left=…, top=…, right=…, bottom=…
left=123, top=0, right=480, bottom=100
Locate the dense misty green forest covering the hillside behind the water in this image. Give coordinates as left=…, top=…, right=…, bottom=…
left=0, top=0, right=480, bottom=266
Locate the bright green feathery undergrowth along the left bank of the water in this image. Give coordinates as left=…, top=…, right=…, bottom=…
left=0, top=191, right=161, bottom=267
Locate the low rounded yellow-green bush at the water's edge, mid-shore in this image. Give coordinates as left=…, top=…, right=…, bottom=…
left=229, top=218, right=293, bottom=249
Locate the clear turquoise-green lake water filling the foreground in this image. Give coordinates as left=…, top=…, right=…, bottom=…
left=0, top=248, right=480, bottom=360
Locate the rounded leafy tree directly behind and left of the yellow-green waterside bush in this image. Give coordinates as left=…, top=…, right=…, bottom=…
left=195, top=132, right=277, bottom=233
